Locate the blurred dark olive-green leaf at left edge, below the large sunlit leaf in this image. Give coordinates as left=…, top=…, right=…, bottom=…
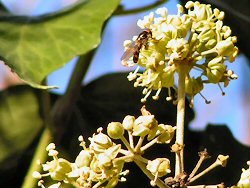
left=0, top=86, right=42, bottom=165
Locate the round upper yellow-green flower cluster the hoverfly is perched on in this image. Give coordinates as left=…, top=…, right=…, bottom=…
left=124, top=1, right=238, bottom=105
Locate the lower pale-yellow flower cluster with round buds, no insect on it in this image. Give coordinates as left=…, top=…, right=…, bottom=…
left=33, top=107, right=175, bottom=188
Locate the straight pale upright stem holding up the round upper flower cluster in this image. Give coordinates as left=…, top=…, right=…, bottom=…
left=175, top=66, right=186, bottom=177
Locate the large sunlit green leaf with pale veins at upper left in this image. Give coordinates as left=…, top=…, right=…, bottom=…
left=0, top=0, right=120, bottom=88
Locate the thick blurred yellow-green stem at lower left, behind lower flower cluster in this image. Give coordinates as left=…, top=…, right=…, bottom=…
left=22, top=128, right=52, bottom=188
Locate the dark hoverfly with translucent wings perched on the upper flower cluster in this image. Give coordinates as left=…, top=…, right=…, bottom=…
left=121, top=29, right=152, bottom=66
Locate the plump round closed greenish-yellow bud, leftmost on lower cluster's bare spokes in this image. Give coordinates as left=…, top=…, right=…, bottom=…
left=107, top=122, right=124, bottom=139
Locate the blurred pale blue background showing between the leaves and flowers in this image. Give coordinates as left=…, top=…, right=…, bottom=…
left=0, top=0, right=250, bottom=146
